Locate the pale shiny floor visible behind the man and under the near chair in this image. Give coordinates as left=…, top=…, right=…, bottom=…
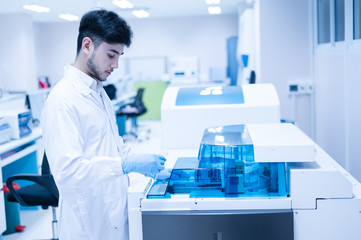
left=0, top=120, right=162, bottom=240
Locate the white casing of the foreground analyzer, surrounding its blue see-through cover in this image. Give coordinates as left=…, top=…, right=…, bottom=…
left=128, top=124, right=361, bottom=240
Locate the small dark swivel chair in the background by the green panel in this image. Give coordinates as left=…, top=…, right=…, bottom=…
left=116, top=88, right=150, bottom=141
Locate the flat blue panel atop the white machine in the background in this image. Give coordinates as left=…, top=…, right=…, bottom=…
left=176, top=86, right=244, bottom=106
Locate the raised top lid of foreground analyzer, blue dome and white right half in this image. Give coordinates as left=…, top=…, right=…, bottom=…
left=199, top=123, right=315, bottom=162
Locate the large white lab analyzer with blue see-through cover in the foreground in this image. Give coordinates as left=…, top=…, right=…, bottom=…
left=128, top=123, right=361, bottom=240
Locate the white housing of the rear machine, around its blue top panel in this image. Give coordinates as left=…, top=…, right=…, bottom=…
left=161, top=84, right=280, bottom=149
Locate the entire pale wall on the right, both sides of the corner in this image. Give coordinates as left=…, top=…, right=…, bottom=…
left=253, top=0, right=361, bottom=181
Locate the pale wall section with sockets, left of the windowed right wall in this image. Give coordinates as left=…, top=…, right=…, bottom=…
left=256, top=0, right=312, bottom=136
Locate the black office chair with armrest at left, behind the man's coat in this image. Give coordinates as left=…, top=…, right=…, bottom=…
left=6, top=153, right=59, bottom=240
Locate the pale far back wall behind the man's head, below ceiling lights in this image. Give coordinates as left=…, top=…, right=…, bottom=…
left=35, top=15, right=238, bottom=84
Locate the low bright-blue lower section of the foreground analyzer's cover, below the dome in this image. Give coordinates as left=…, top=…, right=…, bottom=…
left=147, top=158, right=287, bottom=199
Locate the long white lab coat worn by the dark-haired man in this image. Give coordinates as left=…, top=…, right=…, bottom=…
left=41, top=65, right=130, bottom=240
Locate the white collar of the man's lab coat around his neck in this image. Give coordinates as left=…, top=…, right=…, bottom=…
left=64, top=64, right=103, bottom=95
